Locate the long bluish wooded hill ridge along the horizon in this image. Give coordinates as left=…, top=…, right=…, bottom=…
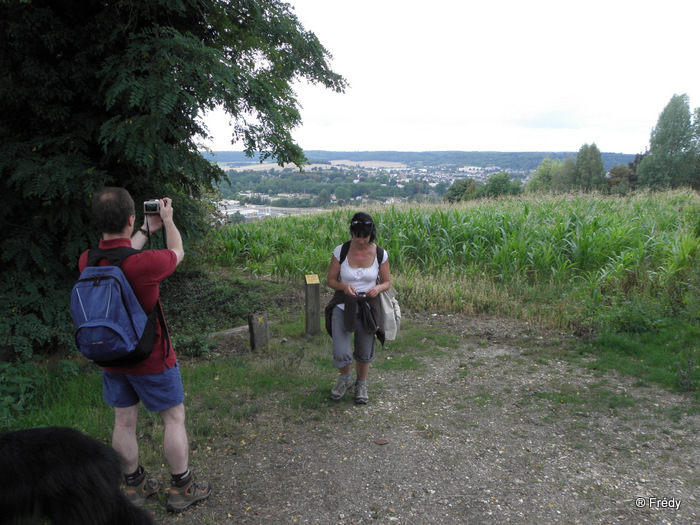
left=204, top=150, right=634, bottom=171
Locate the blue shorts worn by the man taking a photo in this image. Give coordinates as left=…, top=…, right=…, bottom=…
left=102, top=364, right=185, bottom=412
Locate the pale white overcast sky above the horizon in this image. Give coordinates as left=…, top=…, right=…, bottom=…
left=200, top=0, right=700, bottom=153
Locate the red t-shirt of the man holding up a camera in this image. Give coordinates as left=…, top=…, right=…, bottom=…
left=78, top=237, right=177, bottom=375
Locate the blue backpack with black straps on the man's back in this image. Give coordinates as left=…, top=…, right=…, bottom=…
left=71, top=247, right=160, bottom=366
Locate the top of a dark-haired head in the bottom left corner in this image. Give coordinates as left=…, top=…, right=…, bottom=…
left=0, top=427, right=153, bottom=525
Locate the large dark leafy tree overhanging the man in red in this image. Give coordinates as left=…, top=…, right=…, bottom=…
left=0, top=0, right=346, bottom=354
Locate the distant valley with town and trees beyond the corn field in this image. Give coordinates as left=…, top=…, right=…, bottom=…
left=205, top=152, right=634, bottom=222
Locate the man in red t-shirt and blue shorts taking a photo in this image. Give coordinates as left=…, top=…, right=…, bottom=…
left=78, top=188, right=211, bottom=512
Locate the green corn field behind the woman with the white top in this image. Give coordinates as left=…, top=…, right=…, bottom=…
left=210, top=191, right=700, bottom=326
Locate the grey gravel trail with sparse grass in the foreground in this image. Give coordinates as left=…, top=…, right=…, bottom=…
left=147, top=317, right=700, bottom=525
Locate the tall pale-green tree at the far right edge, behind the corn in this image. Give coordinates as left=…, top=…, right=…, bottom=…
left=637, top=95, right=700, bottom=189
